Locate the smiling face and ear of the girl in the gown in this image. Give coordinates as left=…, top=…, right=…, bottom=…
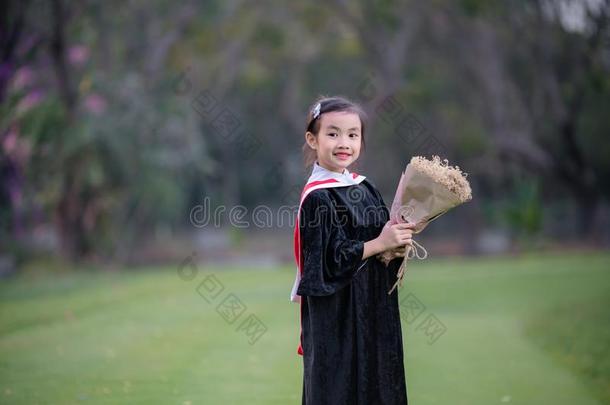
left=305, top=111, right=362, bottom=173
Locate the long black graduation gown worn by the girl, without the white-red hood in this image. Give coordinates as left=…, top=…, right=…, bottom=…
left=297, top=179, right=407, bottom=405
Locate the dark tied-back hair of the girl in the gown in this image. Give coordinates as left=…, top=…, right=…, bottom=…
left=303, top=96, right=367, bottom=167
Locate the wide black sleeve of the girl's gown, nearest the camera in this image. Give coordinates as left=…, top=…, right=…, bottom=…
left=297, top=190, right=366, bottom=296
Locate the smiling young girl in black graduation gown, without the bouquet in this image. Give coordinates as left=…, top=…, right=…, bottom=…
left=290, top=97, right=412, bottom=405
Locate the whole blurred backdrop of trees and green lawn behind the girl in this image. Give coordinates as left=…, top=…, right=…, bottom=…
left=0, top=0, right=610, bottom=404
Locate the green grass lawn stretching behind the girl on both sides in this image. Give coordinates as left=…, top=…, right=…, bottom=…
left=0, top=253, right=610, bottom=405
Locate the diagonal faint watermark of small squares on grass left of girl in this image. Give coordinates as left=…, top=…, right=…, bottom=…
left=177, top=253, right=267, bottom=345
